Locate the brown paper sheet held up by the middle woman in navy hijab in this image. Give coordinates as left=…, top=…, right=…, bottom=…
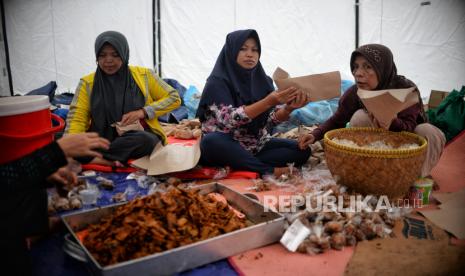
left=273, top=67, right=341, bottom=102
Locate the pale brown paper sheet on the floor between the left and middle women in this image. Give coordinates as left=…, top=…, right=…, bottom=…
left=132, top=139, right=200, bottom=175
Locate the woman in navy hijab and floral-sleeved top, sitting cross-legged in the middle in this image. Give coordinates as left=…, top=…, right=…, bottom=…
left=197, top=30, right=310, bottom=176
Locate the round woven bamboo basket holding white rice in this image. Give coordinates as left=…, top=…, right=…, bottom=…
left=324, top=128, right=427, bottom=199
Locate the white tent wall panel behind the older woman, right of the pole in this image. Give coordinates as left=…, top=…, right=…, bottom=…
left=360, top=0, right=465, bottom=97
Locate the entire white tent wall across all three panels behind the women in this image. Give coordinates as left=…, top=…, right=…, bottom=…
left=4, top=0, right=465, bottom=99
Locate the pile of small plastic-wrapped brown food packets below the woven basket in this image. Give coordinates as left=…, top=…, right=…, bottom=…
left=286, top=184, right=409, bottom=255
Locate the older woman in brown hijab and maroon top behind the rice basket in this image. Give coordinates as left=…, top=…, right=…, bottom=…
left=299, top=44, right=446, bottom=176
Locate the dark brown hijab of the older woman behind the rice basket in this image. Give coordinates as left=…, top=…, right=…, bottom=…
left=350, top=44, right=427, bottom=122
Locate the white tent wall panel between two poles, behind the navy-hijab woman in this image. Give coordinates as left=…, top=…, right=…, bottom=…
left=161, top=0, right=355, bottom=92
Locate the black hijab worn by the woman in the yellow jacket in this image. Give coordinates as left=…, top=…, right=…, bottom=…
left=90, top=31, right=145, bottom=141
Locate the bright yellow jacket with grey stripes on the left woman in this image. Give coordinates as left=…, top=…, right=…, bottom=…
left=65, top=66, right=181, bottom=144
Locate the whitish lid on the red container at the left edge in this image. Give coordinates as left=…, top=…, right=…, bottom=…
left=0, top=95, right=50, bottom=116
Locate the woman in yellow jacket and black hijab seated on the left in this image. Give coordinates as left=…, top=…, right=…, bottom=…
left=65, top=31, right=181, bottom=166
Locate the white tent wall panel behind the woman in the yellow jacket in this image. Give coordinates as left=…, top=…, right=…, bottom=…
left=4, top=0, right=153, bottom=94
